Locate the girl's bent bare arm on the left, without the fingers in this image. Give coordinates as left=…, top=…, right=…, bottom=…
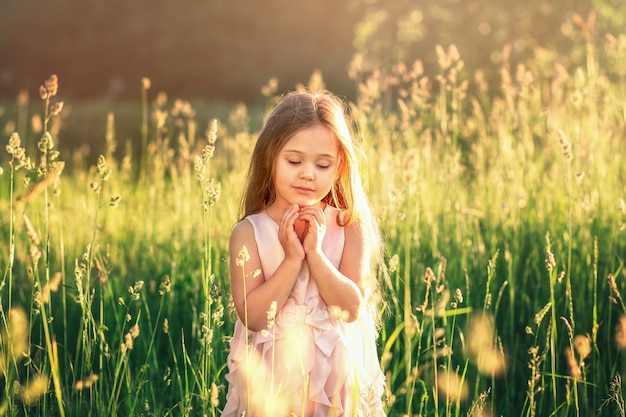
left=229, top=211, right=304, bottom=331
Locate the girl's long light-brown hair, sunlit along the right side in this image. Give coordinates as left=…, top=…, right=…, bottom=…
left=240, top=90, right=384, bottom=316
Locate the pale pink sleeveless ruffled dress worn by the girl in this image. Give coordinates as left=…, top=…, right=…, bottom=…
left=222, top=207, right=385, bottom=417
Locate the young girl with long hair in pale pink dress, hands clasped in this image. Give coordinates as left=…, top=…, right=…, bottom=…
left=222, top=91, right=385, bottom=417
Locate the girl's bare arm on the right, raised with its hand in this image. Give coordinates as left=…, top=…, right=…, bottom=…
left=301, top=206, right=369, bottom=322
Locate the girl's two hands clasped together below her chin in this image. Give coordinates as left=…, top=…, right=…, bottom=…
left=278, top=204, right=326, bottom=259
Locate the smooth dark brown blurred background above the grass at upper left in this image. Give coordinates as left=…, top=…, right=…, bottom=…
left=0, top=0, right=356, bottom=99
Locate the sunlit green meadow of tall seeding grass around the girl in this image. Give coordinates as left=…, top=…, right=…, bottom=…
left=0, top=24, right=626, bottom=417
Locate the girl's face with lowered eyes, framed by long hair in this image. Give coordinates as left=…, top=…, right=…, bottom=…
left=274, top=124, right=340, bottom=209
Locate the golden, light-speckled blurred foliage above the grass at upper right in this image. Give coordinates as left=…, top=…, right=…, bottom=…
left=353, top=0, right=626, bottom=82
